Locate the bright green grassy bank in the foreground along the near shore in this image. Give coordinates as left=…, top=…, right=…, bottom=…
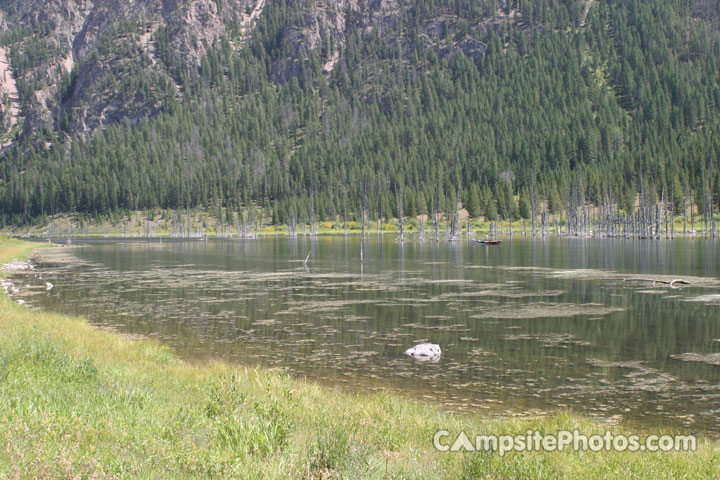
left=0, top=237, right=720, bottom=479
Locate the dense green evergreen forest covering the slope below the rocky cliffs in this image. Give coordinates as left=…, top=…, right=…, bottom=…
left=0, top=0, right=720, bottom=232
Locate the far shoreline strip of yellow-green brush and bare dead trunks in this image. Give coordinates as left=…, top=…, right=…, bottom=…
left=0, top=207, right=718, bottom=241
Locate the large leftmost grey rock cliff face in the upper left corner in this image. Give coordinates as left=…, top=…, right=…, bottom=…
left=0, top=0, right=265, bottom=145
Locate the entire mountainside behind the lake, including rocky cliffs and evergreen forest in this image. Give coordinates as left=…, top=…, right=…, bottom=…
left=0, top=0, right=720, bottom=227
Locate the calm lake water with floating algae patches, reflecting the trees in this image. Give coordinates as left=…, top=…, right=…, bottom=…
left=12, top=235, right=720, bottom=435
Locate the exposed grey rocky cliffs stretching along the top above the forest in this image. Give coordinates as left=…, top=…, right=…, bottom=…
left=0, top=0, right=608, bottom=144
